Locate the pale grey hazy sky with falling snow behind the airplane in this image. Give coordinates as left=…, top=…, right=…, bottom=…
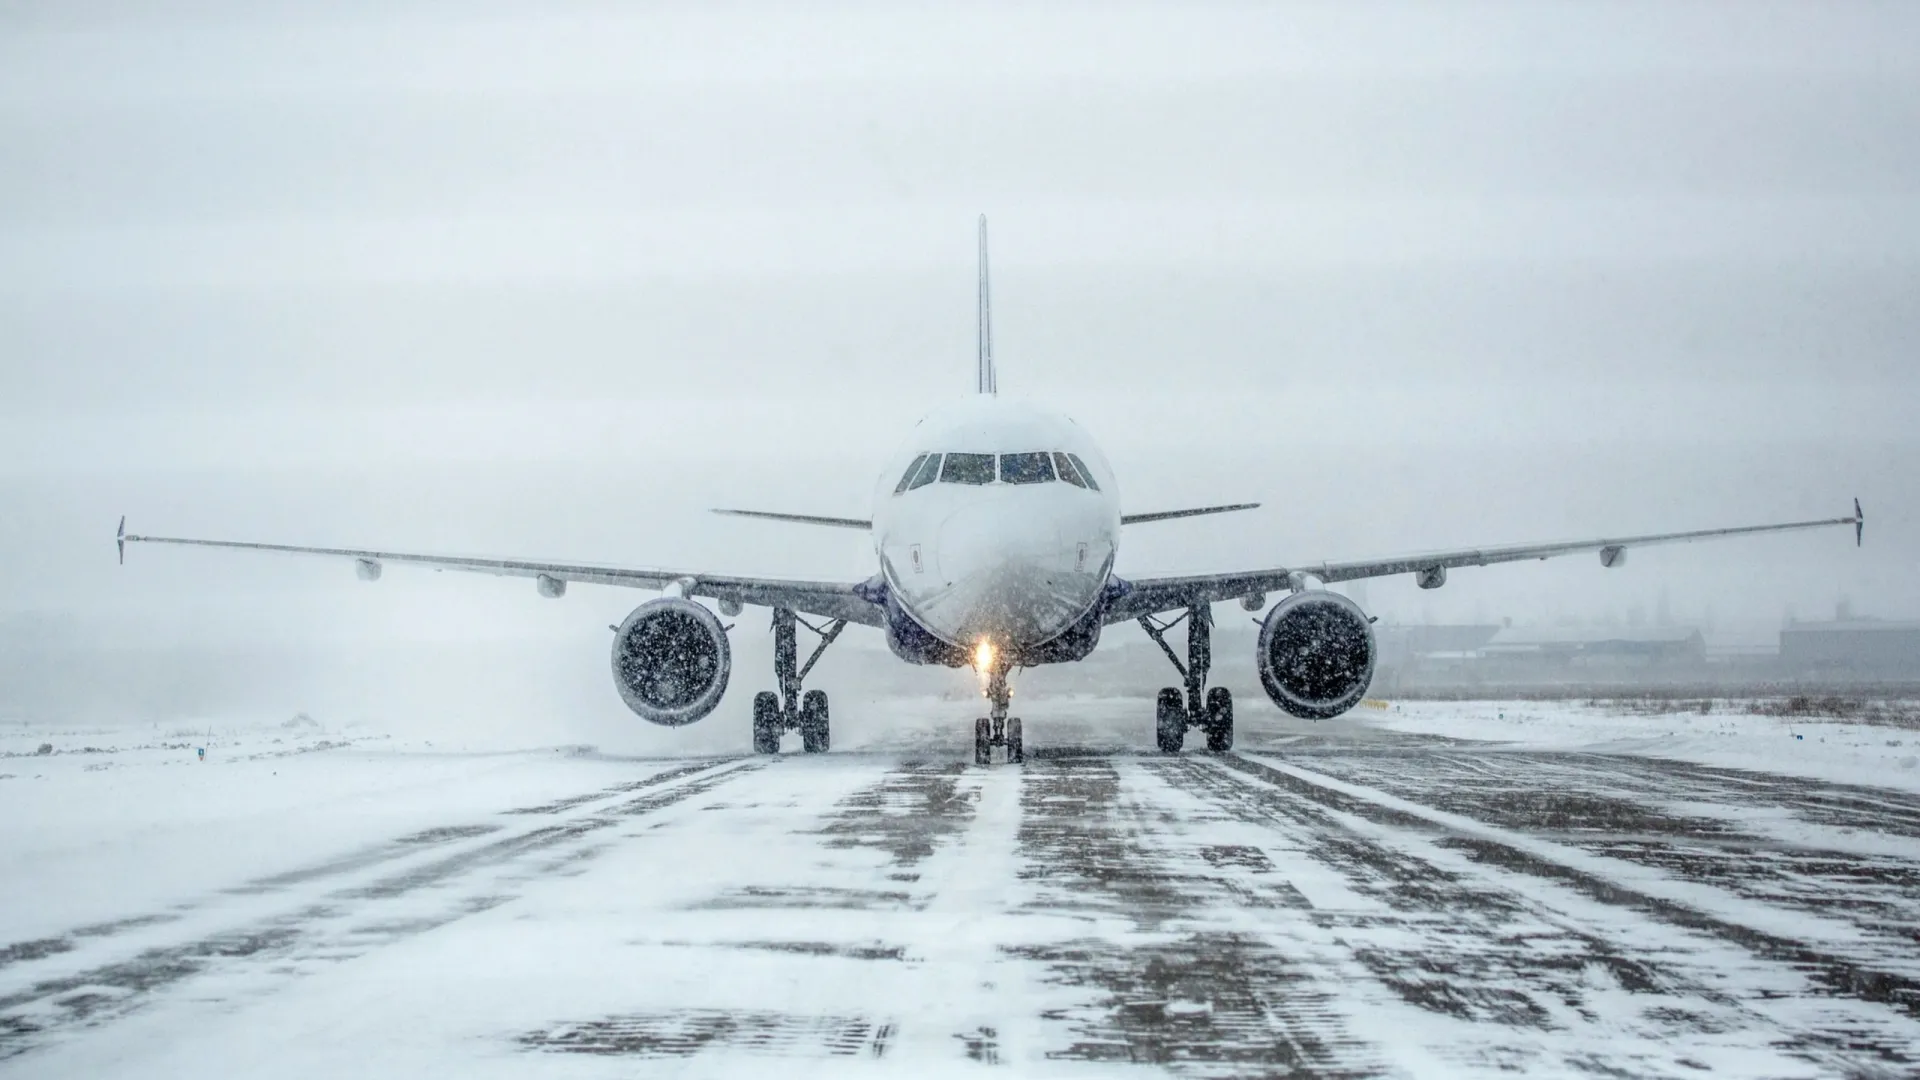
left=0, top=2, right=1920, bottom=748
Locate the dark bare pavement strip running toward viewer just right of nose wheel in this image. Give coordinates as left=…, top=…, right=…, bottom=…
left=1006, top=755, right=1379, bottom=1076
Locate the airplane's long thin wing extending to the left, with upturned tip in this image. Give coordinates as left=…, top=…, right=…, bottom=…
left=115, top=517, right=885, bottom=626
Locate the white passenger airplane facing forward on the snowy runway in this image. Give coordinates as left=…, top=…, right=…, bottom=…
left=117, top=215, right=1864, bottom=765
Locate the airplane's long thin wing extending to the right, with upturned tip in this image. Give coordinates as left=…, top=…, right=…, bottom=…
left=1106, top=500, right=1866, bottom=623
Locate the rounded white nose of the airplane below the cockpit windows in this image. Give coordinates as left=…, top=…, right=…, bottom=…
left=920, top=503, right=1104, bottom=646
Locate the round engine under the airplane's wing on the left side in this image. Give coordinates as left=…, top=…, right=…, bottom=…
left=612, top=596, right=733, bottom=728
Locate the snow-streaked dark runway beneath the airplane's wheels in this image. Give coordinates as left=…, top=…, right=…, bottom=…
left=0, top=707, right=1920, bottom=1078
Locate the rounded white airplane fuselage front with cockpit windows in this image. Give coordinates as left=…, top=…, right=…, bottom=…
left=872, top=394, right=1119, bottom=665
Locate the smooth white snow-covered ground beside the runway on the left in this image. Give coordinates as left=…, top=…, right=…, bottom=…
left=0, top=726, right=664, bottom=949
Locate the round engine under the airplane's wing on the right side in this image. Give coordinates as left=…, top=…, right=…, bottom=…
left=1254, top=590, right=1379, bottom=721
